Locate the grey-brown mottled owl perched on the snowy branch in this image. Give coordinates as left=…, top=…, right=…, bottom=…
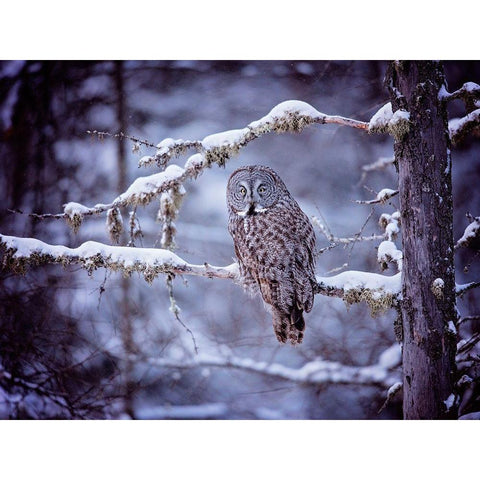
left=227, top=165, right=316, bottom=345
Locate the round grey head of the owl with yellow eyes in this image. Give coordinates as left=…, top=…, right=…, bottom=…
left=227, top=165, right=286, bottom=216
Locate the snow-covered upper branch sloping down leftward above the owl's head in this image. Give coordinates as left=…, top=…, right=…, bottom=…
left=22, top=100, right=368, bottom=235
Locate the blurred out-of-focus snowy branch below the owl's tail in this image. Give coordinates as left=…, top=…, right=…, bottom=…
left=134, top=344, right=401, bottom=388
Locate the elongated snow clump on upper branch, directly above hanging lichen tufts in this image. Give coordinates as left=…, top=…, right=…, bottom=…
left=113, top=165, right=185, bottom=203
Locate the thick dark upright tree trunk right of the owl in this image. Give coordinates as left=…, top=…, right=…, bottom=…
left=386, top=61, right=456, bottom=419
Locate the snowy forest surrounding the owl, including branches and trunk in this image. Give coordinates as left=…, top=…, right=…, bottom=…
left=0, top=60, right=480, bottom=420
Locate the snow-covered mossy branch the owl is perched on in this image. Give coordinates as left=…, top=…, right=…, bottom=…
left=0, top=235, right=401, bottom=313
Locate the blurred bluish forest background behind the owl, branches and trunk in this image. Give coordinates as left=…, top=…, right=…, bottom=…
left=0, top=61, right=480, bottom=419
